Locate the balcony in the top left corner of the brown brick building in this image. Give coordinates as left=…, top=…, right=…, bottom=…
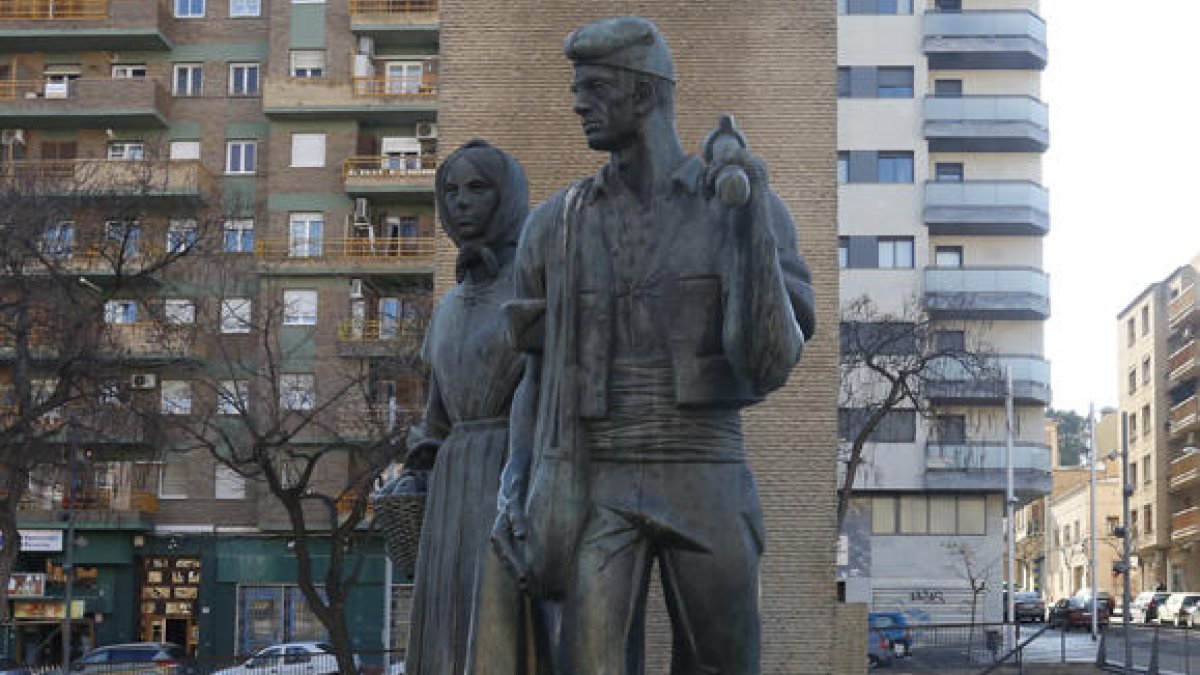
left=0, top=0, right=172, bottom=53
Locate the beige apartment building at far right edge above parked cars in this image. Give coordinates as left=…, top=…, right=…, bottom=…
left=1117, top=251, right=1200, bottom=591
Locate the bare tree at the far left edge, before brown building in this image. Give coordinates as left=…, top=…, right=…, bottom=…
left=0, top=145, right=214, bottom=619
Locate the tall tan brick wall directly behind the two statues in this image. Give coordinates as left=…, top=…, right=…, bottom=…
left=437, top=0, right=838, bottom=673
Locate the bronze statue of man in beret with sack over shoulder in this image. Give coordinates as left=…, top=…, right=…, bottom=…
left=493, top=17, right=814, bottom=675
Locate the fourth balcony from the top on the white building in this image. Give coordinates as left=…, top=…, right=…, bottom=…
left=925, top=267, right=1050, bottom=321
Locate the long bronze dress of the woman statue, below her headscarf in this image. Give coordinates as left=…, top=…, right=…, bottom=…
left=406, top=265, right=523, bottom=675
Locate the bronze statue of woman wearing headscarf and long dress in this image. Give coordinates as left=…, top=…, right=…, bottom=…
left=385, top=141, right=540, bottom=675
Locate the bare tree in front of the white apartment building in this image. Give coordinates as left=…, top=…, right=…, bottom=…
left=838, top=295, right=1003, bottom=531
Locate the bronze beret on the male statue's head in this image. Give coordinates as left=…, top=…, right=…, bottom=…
left=563, top=17, right=676, bottom=82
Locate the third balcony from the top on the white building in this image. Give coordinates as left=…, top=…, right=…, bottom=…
left=925, top=180, right=1050, bottom=237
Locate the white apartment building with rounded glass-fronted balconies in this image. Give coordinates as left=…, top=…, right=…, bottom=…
left=838, top=0, right=1050, bottom=621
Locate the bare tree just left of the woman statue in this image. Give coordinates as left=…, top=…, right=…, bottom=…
left=139, top=265, right=426, bottom=675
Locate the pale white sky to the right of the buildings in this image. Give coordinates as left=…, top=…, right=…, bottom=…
left=1040, top=0, right=1200, bottom=414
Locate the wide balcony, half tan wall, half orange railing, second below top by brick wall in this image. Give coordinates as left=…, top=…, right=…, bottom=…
left=263, top=73, right=438, bottom=124
